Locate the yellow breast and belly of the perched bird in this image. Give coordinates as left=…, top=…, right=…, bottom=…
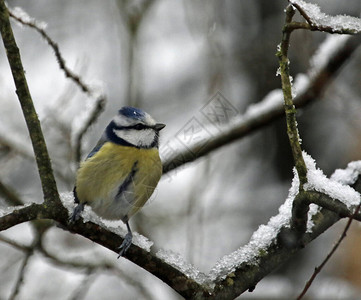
left=76, top=142, right=162, bottom=221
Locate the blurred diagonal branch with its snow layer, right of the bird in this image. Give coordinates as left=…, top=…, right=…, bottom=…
left=161, top=31, right=361, bottom=173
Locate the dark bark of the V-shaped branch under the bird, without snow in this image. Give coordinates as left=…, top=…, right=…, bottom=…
left=0, top=154, right=361, bottom=299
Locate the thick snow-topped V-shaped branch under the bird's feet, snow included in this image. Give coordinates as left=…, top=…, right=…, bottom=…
left=60, top=154, right=361, bottom=299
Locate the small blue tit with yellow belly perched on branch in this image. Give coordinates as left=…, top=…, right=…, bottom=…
left=71, top=107, right=165, bottom=258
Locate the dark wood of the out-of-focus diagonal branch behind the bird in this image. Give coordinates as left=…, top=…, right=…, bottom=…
left=163, top=35, right=361, bottom=174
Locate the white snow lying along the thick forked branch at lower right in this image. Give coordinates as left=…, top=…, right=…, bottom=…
left=209, top=152, right=361, bottom=281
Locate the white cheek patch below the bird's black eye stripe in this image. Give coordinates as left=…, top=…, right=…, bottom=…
left=114, top=128, right=156, bottom=147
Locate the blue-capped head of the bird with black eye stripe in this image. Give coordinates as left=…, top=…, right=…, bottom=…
left=105, top=106, right=165, bottom=148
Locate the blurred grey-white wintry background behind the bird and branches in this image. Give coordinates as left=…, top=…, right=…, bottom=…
left=0, top=0, right=361, bottom=299
